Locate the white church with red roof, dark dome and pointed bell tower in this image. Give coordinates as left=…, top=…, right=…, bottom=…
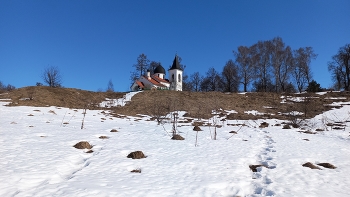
left=131, top=55, right=183, bottom=91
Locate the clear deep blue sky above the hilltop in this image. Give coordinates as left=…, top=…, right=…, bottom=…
left=0, top=0, right=350, bottom=91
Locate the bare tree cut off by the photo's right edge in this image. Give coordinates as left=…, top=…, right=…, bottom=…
left=328, top=44, right=350, bottom=91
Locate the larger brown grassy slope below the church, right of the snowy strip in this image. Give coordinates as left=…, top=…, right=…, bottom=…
left=114, top=91, right=350, bottom=119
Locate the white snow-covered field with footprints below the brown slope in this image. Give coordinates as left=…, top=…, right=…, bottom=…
left=0, top=95, right=350, bottom=197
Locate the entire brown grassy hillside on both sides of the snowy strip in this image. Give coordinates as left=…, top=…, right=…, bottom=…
left=0, top=86, right=350, bottom=121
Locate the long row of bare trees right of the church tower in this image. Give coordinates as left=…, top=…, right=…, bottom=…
left=183, top=37, right=317, bottom=92
